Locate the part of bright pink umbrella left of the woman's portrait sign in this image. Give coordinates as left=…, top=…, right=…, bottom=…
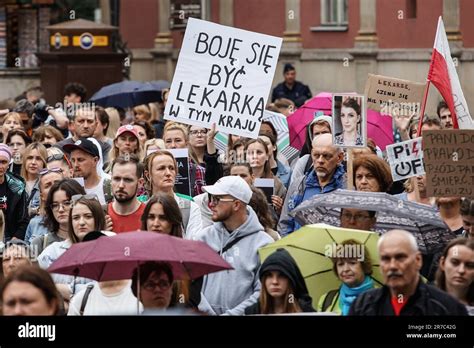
left=287, top=92, right=332, bottom=150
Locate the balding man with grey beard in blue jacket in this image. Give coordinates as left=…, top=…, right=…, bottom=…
left=278, top=134, right=346, bottom=235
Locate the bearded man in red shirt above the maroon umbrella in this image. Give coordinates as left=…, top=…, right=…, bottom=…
left=107, top=154, right=145, bottom=233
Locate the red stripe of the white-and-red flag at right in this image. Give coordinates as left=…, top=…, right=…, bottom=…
left=428, top=48, right=459, bottom=129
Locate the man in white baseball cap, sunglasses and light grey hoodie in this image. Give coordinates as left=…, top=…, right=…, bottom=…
left=192, top=176, right=273, bottom=315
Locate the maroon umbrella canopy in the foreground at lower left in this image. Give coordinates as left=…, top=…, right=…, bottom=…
left=48, top=231, right=232, bottom=281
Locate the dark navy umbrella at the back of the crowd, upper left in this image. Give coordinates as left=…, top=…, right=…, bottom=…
left=90, top=81, right=161, bottom=108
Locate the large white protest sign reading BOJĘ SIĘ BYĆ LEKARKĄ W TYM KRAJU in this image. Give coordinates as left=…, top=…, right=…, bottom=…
left=164, top=18, right=282, bottom=138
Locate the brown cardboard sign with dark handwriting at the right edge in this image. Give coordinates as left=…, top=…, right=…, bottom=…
left=423, top=129, right=474, bottom=197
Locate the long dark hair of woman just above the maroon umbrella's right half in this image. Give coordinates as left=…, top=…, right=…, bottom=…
left=141, top=193, right=183, bottom=238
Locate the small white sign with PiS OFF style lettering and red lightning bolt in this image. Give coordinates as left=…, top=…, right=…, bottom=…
left=387, top=137, right=425, bottom=181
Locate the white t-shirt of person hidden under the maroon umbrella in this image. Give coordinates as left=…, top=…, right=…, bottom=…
left=67, top=280, right=143, bottom=315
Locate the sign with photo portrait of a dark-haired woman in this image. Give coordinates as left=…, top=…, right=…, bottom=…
left=332, top=94, right=367, bottom=147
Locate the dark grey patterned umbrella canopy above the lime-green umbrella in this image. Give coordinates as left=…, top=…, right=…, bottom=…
left=290, top=190, right=456, bottom=254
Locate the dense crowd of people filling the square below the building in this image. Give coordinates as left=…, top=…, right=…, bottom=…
left=0, top=68, right=474, bottom=315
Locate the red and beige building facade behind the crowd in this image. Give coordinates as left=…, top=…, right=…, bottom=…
left=120, top=0, right=474, bottom=113
